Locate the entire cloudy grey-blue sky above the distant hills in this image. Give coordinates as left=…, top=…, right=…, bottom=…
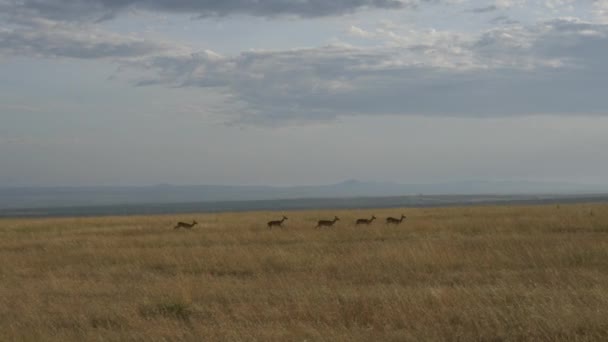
left=0, top=0, right=608, bottom=187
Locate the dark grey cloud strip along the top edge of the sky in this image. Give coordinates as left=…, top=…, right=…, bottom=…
left=0, top=0, right=437, bottom=20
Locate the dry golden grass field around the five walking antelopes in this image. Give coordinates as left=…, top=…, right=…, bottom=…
left=0, top=204, right=608, bottom=341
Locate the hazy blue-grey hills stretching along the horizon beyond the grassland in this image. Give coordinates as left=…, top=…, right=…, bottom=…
left=0, top=180, right=608, bottom=209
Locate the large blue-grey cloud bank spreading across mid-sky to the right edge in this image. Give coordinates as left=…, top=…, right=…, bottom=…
left=127, top=19, right=608, bottom=122
